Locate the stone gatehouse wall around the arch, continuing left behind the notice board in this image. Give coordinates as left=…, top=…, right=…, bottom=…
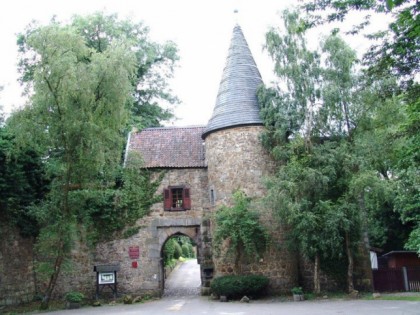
left=51, top=168, right=208, bottom=297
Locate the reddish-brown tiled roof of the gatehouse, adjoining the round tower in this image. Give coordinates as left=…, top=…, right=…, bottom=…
left=128, top=126, right=206, bottom=168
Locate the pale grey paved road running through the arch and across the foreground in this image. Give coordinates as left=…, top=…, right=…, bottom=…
left=36, top=261, right=420, bottom=315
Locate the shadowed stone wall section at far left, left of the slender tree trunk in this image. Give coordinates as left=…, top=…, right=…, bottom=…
left=0, top=225, right=35, bottom=306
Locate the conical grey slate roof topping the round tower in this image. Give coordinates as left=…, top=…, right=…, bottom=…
left=203, top=25, right=263, bottom=139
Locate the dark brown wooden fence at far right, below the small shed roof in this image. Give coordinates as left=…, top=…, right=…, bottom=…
left=373, top=267, right=420, bottom=292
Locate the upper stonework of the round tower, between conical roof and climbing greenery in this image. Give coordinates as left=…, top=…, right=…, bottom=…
left=206, top=126, right=275, bottom=206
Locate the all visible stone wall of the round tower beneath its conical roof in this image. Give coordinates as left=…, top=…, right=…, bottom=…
left=206, top=126, right=298, bottom=293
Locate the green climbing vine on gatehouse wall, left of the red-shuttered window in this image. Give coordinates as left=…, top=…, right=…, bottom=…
left=74, top=166, right=164, bottom=245
